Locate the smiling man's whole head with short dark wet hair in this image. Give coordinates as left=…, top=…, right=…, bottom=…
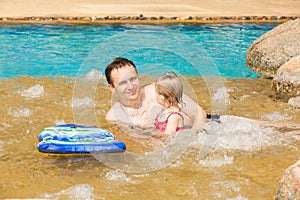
left=105, top=58, right=140, bottom=104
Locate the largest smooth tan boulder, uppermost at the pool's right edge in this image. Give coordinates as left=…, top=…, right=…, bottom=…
left=246, top=19, right=300, bottom=78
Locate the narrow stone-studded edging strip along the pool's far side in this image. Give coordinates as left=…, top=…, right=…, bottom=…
left=0, top=14, right=300, bottom=24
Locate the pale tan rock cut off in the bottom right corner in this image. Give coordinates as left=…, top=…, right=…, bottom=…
left=276, top=160, right=300, bottom=200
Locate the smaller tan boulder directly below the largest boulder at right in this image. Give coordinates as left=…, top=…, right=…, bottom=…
left=272, top=55, right=300, bottom=96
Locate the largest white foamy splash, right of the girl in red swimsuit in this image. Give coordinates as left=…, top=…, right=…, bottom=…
left=198, top=115, right=282, bottom=153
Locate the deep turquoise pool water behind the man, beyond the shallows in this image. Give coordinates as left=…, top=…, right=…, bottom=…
left=0, top=24, right=276, bottom=79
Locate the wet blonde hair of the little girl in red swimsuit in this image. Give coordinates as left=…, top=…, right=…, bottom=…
left=155, top=72, right=183, bottom=108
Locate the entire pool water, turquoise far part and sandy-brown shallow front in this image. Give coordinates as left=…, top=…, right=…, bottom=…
left=0, top=24, right=300, bottom=200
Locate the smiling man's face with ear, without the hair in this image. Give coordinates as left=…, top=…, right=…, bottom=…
left=108, top=66, right=140, bottom=101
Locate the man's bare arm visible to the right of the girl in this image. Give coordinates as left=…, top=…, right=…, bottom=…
left=182, top=94, right=206, bottom=129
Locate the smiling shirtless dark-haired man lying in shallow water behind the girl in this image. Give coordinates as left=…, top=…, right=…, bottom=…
left=105, top=58, right=206, bottom=128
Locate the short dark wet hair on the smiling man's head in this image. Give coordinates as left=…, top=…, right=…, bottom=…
left=105, top=57, right=137, bottom=86
